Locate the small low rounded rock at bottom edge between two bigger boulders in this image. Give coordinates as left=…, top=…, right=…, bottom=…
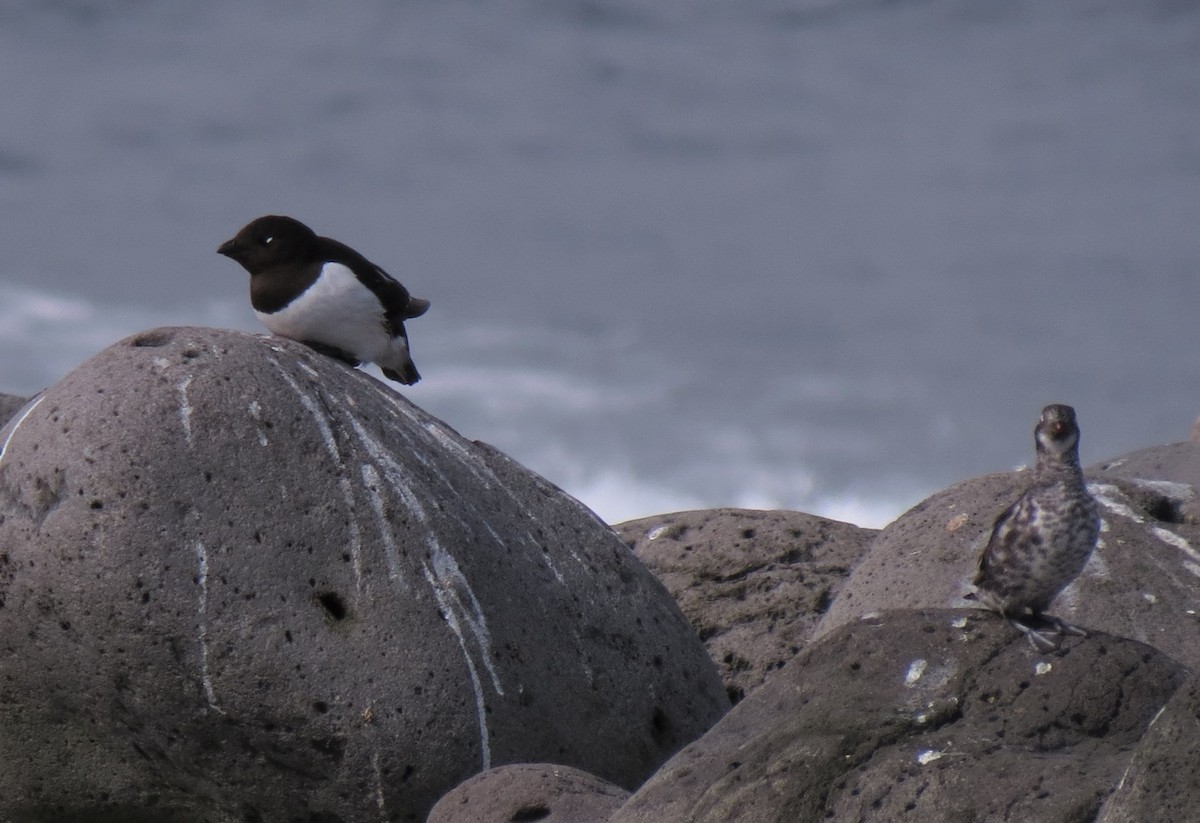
left=426, top=763, right=629, bottom=823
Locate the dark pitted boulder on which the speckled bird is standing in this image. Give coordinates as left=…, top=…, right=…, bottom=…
left=611, top=609, right=1192, bottom=823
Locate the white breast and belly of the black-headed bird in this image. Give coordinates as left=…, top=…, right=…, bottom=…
left=254, top=263, right=390, bottom=362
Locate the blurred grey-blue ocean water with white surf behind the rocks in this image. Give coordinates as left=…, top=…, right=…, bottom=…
left=0, top=0, right=1200, bottom=525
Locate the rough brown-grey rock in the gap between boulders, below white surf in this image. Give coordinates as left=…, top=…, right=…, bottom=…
left=614, top=509, right=877, bottom=702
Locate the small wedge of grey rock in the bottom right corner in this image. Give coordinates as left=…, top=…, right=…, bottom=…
left=1097, top=679, right=1200, bottom=823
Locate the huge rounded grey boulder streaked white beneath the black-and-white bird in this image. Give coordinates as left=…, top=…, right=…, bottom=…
left=0, top=329, right=727, bottom=823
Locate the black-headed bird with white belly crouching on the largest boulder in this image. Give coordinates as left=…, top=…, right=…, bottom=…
left=217, top=215, right=430, bottom=385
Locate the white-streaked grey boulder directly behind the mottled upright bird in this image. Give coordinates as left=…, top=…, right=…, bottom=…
left=816, top=453, right=1200, bottom=667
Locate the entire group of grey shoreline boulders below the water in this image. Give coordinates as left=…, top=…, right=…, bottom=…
left=0, top=328, right=1200, bottom=823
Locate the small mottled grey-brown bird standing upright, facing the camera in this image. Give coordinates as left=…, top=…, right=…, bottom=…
left=967, top=403, right=1100, bottom=651
